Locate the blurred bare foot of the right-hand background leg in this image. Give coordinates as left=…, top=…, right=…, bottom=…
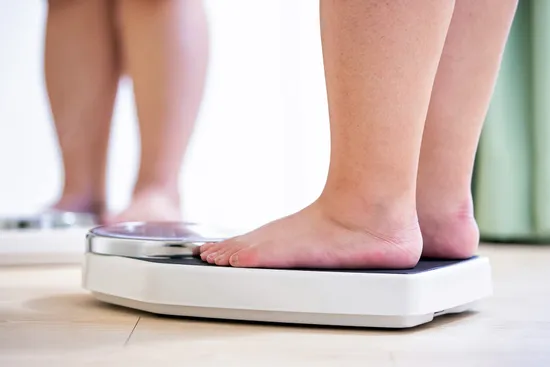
left=105, top=190, right=181, bottom=223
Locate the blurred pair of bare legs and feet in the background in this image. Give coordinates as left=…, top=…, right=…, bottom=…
left=45, top=0, right=208, bottom=222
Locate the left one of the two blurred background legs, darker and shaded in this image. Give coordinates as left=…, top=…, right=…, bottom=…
left=45, top=0, right=119, bottom=214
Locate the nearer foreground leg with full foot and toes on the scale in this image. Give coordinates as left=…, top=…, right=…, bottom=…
left=201, top=0, right=454, bottom=268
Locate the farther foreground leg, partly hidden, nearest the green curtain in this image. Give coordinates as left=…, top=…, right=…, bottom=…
left=417, top=0, right=517, bottom=258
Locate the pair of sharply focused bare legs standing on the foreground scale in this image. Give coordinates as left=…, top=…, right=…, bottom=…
left=200, top=0, right=517, bottom=268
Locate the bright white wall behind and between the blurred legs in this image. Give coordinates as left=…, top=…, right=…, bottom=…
left=0, top=0, right=329, bottom=233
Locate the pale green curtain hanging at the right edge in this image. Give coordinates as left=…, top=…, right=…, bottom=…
left=473, top=0, right=550, bottom=242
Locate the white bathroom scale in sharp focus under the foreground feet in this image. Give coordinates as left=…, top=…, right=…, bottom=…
left=82, top=223, right=492, bottom=328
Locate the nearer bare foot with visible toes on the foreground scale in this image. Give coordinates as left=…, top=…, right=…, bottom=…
left=200, top=202, right=422, bottom=269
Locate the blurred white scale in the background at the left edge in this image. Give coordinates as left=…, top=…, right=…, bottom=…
left=0, top=210, right=98, bottom=265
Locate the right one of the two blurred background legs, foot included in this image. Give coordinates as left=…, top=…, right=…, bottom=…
left=112, top=0, right=208, bottom=221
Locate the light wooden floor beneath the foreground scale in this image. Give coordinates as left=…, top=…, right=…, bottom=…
left=0, top=245, right=550, bottom=367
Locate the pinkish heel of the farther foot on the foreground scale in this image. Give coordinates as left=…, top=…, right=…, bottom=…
left=419, top=206, right=479, bottom=259
